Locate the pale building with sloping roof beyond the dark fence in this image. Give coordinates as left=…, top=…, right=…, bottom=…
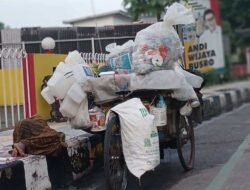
left=63, top=10, right=132, bottom=27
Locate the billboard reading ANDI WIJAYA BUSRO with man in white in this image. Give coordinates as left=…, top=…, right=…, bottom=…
left=183, top=0, right=225, bottom=73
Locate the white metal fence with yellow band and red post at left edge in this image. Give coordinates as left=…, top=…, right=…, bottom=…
left=0, top=47, right=31, bottom=130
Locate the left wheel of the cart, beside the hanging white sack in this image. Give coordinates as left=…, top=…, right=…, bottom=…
left=104, top=113, right=127, bottom=190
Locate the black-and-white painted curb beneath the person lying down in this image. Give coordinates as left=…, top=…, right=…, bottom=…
left=0, top=125, right=103, bottom=190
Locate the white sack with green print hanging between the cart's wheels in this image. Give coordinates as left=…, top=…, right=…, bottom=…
left=111, top=98, right=160, bottom=178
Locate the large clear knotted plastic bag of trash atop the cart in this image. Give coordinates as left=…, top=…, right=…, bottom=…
left=133, top=3, right=195, bottom=74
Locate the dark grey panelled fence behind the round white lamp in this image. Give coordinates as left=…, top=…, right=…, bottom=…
left=20, top=24, right=150, bottom=54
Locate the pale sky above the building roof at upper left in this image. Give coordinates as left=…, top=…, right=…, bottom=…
left=0, top=0, right=123, bottom=28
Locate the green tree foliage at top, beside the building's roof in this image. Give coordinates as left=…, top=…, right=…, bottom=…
left=123, top=0, right=176, bottom=20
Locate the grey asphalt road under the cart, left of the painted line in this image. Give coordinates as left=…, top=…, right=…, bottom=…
left=70, top=104, right=250, bottom=190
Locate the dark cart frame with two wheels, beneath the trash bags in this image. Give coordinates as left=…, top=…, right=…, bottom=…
left=95, top=90, right=195, bottom=190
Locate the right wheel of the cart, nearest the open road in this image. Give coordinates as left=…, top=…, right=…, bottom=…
left=176, top=114, right=195, bottom=171
